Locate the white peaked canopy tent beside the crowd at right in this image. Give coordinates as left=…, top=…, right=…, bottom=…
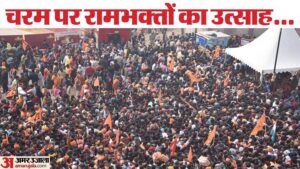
left=225, top=28, right=300, bottom=74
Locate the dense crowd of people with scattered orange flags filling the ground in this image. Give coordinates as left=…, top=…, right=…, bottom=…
left=0, top=31, right=300, bottom=169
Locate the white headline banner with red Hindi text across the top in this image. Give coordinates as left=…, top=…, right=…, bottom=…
left=0, top=0, right=300, bottom=28
